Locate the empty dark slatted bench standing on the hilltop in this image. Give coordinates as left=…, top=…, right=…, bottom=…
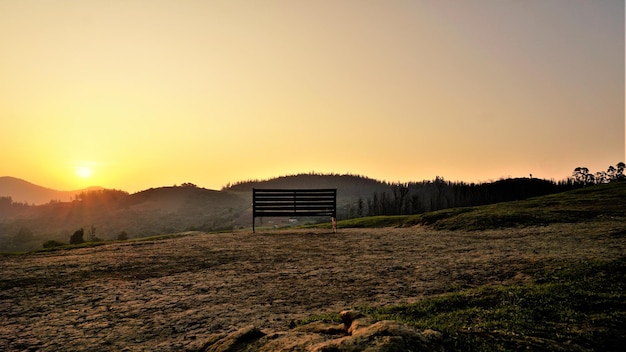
left=252, top=188, right=337, bottom=233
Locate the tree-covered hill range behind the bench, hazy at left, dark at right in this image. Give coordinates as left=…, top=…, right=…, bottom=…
left=0, top=174, right=570, bottom=251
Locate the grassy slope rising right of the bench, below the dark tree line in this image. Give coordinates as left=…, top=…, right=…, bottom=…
left=332, top=182, right=626, bottom=231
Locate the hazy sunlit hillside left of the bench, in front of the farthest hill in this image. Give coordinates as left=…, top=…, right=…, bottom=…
left=0, top=187, right=246, bottom=251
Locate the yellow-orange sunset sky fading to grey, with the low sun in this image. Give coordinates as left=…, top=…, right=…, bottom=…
left=0, top=0, right=626, bottom=193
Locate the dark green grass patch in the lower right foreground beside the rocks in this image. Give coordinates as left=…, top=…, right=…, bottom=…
left=299, top=258, right=626, bottom=351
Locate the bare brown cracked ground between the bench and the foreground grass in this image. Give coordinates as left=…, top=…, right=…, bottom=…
left=0, top=224, right=625, bottom=351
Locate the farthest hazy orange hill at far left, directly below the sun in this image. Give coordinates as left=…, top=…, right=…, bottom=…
left=0, top=176, right=102, bottom=205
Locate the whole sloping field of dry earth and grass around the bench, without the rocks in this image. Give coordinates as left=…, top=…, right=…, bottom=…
left=0, top=183, right=626, bottom=351
